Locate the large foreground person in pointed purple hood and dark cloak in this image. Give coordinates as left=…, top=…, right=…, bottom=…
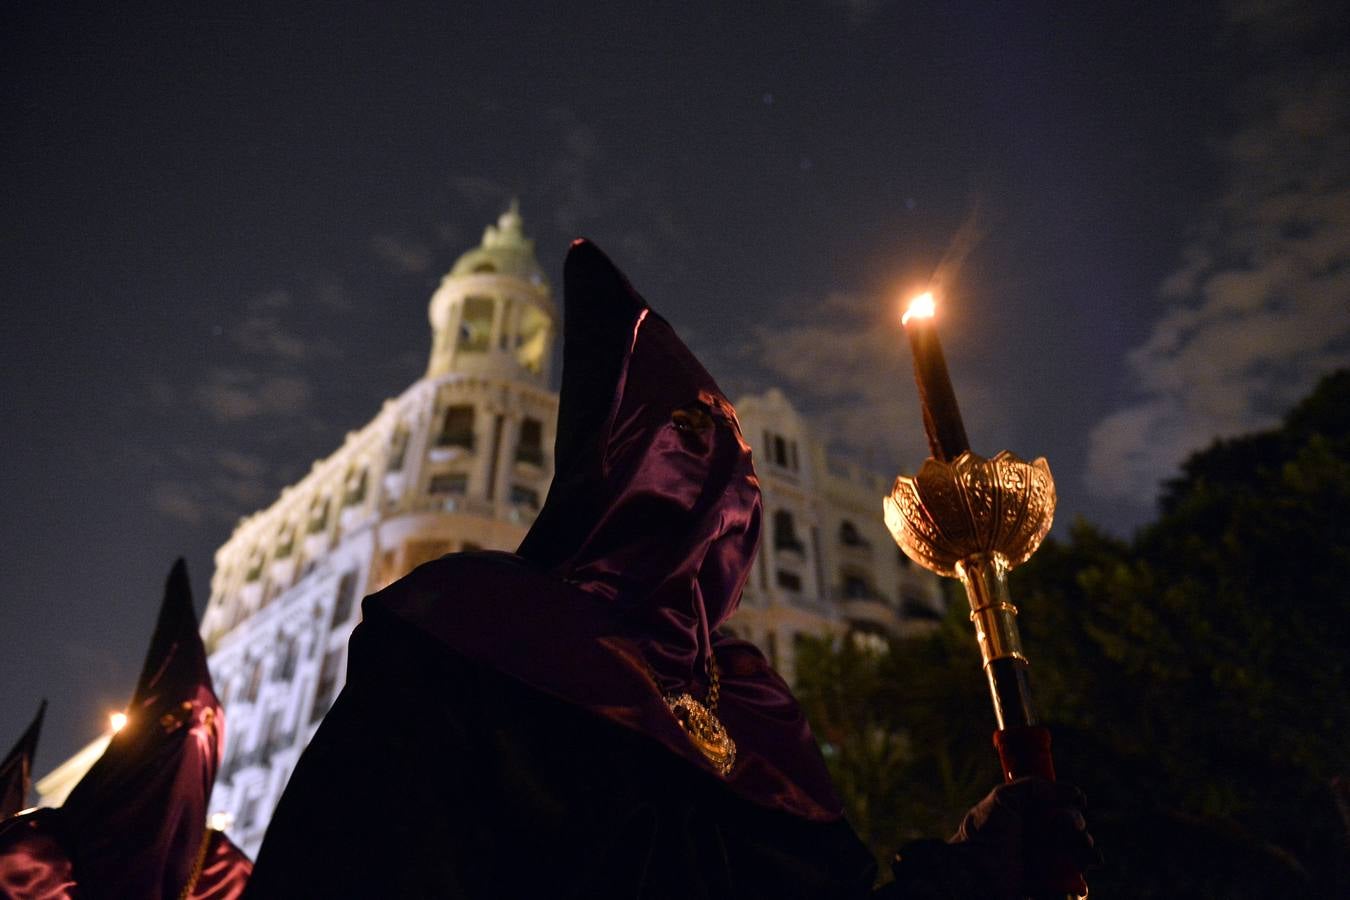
left=248, top=242, right=875, bottom=900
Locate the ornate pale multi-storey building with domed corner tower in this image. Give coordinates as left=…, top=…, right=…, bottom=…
left=38, top=206, right=941, bottom=854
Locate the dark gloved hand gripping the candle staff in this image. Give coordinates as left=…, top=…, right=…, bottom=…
left=892, top=777, right=1102, bottom=900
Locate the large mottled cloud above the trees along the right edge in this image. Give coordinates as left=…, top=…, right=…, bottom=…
left=1087, top=4, right=1350, bottom=506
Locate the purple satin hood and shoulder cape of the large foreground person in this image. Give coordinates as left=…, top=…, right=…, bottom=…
left=380, top=240, right=840, bottom=820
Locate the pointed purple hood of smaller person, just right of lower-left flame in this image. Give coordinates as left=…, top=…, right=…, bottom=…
left=62, top=560, right=224, bottom=900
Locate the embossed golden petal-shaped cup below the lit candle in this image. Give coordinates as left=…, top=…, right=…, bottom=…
left=883, top=451, right=1056, bottom=578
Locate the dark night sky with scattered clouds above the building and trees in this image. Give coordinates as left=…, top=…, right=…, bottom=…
left=0, top=0, right=1350, bottom=773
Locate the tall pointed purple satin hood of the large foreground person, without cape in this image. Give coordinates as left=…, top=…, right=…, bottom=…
left=518, top=240, right=760, bottom=690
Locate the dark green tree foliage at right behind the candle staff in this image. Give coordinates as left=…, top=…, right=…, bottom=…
left=799, top=371, right=1350, bottom=897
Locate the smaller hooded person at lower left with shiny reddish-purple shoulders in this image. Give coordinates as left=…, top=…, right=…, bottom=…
left=0, top=560, right=250, bottom=900
